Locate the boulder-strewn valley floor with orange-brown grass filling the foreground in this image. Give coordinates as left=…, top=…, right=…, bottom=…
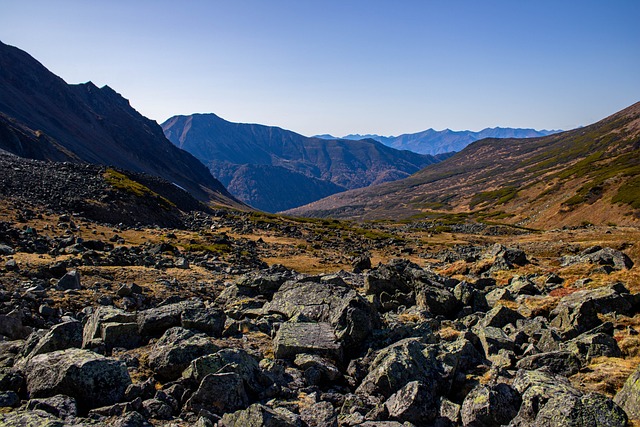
left=0, top=176, right=640, bottom=426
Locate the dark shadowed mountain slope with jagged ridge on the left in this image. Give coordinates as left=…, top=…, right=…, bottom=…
left=0, top=42, right=242, bottom=207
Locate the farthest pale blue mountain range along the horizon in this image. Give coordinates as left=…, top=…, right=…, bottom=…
left=318, top=127, right=560, bottom=155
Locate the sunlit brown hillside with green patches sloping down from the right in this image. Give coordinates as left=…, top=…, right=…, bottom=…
left=287, top=103, right=640, bottom=228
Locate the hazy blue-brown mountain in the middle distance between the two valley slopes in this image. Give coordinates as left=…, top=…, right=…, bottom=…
left=162, top=114, right=448, bottom=212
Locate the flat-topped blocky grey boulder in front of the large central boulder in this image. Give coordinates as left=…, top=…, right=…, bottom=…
left=273, top=322, right=342, bottom=361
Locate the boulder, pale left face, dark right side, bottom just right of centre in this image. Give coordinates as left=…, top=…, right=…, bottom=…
left=385, top=381, right=438, bottom=425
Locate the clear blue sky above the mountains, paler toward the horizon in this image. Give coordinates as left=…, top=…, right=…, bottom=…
left=0, top=0, right=640, bottom=136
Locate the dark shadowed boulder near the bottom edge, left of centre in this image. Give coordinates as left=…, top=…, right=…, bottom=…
left=185, top=372, right=249, bottom=415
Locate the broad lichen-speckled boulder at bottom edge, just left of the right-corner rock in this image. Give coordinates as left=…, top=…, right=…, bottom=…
left=512, top=370, right=627, bottom=427
